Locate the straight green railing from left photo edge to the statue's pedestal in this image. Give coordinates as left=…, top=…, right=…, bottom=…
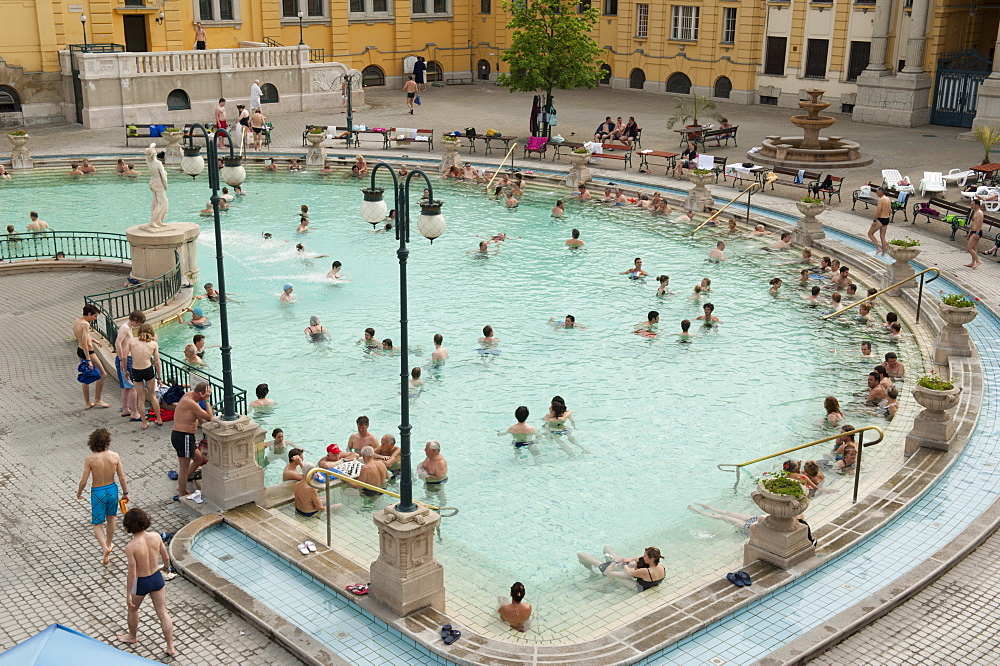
left=0, top=231, right=132, bottom=263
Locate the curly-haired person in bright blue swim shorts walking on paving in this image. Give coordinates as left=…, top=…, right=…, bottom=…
left=76, top=428, right=128, bottom=566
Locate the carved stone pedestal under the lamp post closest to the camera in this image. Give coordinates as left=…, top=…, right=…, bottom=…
left=368, top=504, right=444, bottom=617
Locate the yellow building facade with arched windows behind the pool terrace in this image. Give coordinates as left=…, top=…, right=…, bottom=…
left=0, top=0, right=1000, bottom=124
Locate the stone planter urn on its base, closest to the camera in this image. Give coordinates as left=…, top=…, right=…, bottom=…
left=743, top=483, right=816, bottom=569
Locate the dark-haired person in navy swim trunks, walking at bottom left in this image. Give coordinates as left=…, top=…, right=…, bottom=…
left=118, top=509, right=177, bottom=657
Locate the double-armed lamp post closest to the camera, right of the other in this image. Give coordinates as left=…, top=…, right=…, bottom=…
left=360, top=163, right=445, bottom=513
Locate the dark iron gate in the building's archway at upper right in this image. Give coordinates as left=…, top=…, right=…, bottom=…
left=931, top=51, right=993, bottom=127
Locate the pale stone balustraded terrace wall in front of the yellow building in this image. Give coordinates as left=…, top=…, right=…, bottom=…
left=60, top=47, right=364, bottom=128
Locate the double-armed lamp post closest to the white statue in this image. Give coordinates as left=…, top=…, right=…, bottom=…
left=181, top=123, right=247, bottom=421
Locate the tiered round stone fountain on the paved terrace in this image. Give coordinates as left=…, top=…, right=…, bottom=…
left=748, top=90, right=874, bottom=172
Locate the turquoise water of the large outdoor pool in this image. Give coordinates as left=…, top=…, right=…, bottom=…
left=0, top=171, right=920, bottom=589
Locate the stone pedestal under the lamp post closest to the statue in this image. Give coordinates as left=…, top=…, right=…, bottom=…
left=201, top=416, right=264, bottom=511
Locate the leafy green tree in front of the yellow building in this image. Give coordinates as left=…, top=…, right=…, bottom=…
left=497, top=0, right=604, bottom=136
